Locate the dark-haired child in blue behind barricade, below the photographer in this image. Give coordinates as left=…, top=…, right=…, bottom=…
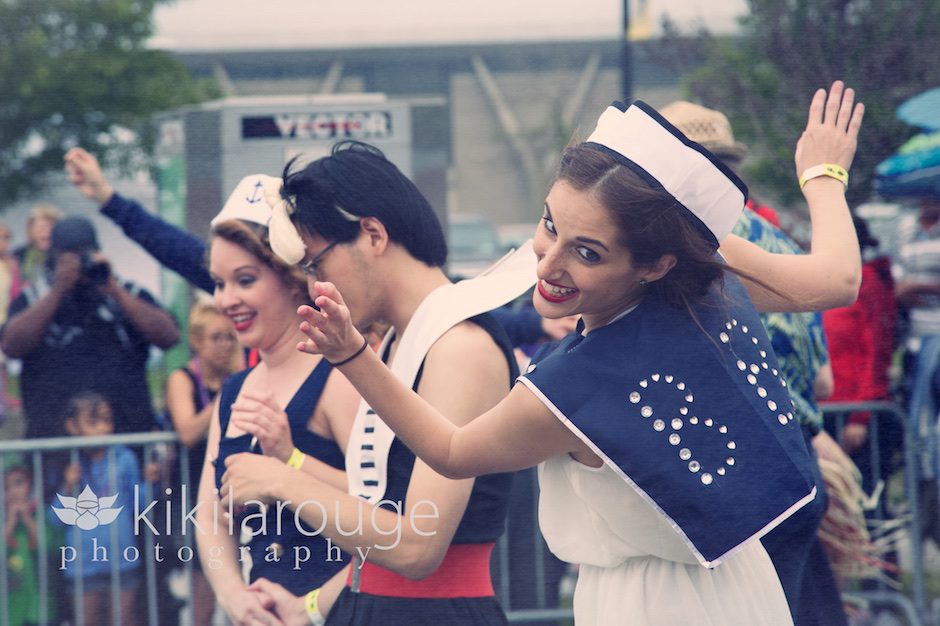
left=53, top=391, right=143, bottom=626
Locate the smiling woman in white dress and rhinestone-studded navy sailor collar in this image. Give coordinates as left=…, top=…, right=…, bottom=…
left=298, top=82, right=863, bottom=626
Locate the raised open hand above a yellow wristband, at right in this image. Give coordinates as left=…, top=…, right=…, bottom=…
left=795, top=80, right=865, bottom=176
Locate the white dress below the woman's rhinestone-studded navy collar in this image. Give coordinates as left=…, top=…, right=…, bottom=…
left=539, top=455, right=793, bottom=626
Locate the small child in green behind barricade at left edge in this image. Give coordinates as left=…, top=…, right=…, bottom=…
left=3, top=464, right=60, bottom=626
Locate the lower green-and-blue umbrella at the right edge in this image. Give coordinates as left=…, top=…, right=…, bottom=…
left=875, top=130, right=940, bottom=198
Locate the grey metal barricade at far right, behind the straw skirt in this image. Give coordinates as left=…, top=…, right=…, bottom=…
left=820, top=402, right=934, bottom=626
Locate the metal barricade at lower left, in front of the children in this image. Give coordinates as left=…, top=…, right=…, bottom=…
left=0, top=432, right=195, bottom=626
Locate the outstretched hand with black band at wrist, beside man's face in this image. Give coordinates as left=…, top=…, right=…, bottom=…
left=297, top=282, right=365, bottom=363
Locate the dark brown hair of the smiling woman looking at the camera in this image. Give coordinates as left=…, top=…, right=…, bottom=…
left=558, top=144, right=727, bottom=308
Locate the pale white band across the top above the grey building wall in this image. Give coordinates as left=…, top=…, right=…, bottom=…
left=153, top=0, right=746, bottom=50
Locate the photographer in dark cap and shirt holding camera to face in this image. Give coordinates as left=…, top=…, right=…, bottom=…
left=0, top=217, right=179, bottom=437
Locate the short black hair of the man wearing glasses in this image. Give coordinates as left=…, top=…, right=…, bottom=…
left=281, top=141, right=447, bottom=267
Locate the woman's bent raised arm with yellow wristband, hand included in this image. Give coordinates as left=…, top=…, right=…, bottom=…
left=721, top=81, right=865, bottom=311
